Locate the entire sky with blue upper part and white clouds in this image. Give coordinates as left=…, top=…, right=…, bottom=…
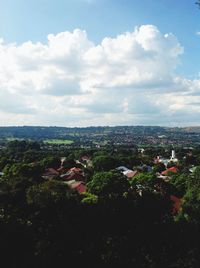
left=0, top=0, right=200, bottom=126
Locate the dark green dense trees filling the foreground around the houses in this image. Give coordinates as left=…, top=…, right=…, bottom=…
left=0, top=141, right=200, bottom=268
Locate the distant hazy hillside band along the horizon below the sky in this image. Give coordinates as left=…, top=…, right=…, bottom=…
left=0, top=126, right=200, bottom=147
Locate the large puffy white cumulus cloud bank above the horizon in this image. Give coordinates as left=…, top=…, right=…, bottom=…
left=0, top=25, right=200, bottom=126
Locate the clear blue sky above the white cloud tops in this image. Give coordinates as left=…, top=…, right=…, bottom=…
left=0, top=0, right=200, bottom=76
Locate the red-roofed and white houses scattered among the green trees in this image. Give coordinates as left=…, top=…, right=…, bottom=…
left=37, top=149, right=196, bottom=213
